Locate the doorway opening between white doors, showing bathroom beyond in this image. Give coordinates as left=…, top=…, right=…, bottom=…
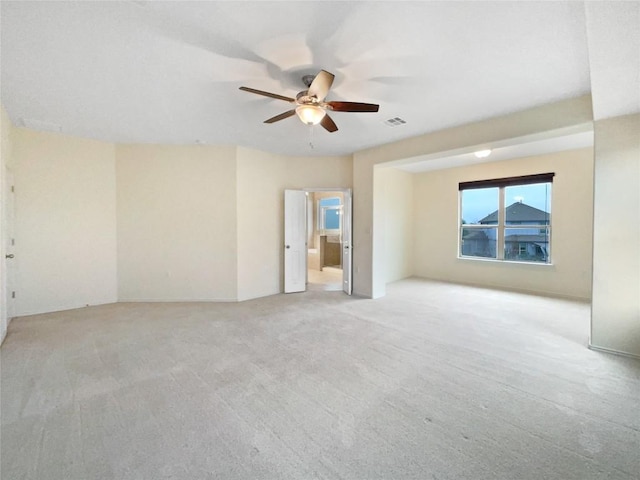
left=307, top=191, right=345, bottom=291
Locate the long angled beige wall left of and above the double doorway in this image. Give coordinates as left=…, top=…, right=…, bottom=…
left=3, top=137, right=352, bottom=315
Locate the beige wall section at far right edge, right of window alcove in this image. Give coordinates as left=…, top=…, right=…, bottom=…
left=591, top=114, right=640, bottom=356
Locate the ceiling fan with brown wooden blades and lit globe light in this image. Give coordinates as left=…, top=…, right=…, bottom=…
left=240, top=70, right=380, bottom=132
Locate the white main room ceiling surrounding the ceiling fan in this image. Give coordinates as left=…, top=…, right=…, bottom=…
left=1, top=0, right=635, bottom=156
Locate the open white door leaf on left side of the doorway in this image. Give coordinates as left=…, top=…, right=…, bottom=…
left=284, top=190, right=307, bottom=293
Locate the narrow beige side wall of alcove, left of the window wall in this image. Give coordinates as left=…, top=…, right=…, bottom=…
left=375, top=168, right=414, bottom=282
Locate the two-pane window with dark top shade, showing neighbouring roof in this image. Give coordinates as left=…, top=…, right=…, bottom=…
left=459, top=173, right=554, bottom=263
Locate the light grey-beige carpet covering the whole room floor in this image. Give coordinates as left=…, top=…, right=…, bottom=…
left=1, top=279, right=640, bottom=480
